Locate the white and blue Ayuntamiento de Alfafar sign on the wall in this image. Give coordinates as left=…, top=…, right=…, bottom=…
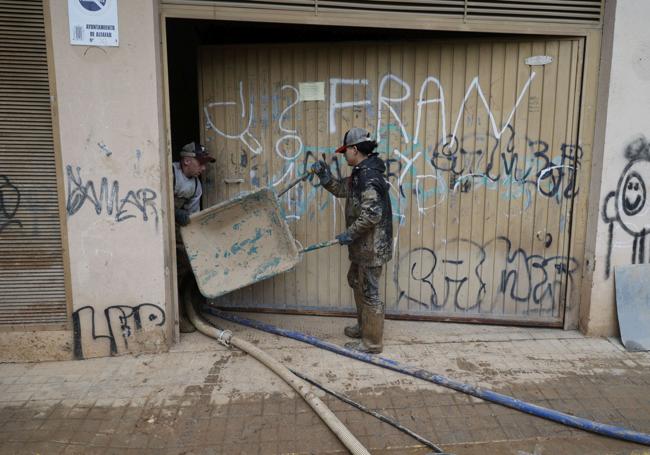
left=68, top=0, right=119, bottom=46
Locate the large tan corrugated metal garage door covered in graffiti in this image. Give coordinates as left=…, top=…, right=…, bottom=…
left=199, top=39, right=587, bottom=326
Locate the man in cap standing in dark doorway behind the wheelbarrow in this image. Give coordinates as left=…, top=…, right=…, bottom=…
left=172, top=142, right=216, bottom=333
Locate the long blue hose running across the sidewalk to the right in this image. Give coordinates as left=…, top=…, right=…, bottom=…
left=203, top=306, right=650, bottom=446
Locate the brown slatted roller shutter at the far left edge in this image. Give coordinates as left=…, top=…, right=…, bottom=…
left=0, top=0, right=67, bottom=327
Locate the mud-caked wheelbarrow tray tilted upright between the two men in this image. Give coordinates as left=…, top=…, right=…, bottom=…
left=181, top=188, right=300, bottom=298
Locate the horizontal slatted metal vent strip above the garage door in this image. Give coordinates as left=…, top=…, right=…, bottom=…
left=162, top=0, right=603, bottom=23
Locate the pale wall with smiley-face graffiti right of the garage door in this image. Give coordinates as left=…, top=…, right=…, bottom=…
left=581, top=0, right=650, bottom=335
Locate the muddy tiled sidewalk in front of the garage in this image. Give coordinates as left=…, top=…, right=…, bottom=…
left=0, top=315, right=650, bottom=455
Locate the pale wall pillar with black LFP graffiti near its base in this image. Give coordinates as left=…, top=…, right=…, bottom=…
left=51, top=0, right=173, bottom=358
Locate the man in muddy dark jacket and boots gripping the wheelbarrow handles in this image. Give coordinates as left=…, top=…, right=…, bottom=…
left=312, top=128, right=393, bottom=354
